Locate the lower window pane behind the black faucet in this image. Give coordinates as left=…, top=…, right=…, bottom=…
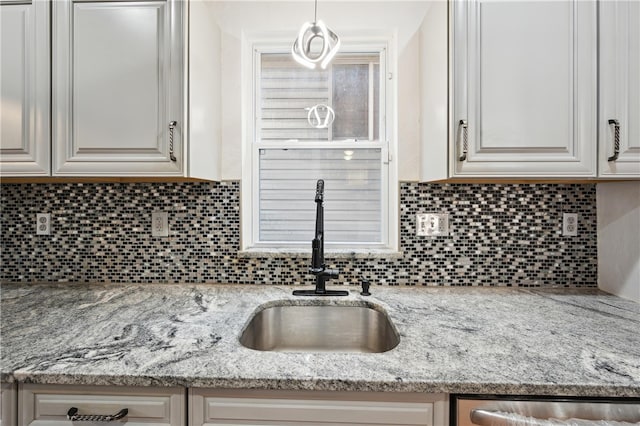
left=259, top=148, right=382, bottom=244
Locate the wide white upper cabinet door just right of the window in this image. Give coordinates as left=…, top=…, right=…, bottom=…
left=450, top=0, right=597, bottom=177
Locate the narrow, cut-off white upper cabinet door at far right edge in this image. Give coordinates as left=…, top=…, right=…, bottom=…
left=599, top=0, right=640, bottom=178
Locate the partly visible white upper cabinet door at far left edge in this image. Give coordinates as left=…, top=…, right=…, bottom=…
left=0, top=1, right=50, bottom=176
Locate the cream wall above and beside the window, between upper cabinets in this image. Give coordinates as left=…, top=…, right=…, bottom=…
left=207, top=0, right=438, bottom=181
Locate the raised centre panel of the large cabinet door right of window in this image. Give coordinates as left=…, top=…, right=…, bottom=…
left=473, top=2, right=574, bottom=151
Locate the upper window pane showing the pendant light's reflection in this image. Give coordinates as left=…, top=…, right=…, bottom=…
left=256, top=53, right=380, bottom=141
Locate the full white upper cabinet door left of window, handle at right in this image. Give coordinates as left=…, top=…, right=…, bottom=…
left=53, top=0, right=184, bottom=176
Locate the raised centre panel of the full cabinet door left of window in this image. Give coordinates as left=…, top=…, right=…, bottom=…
left=72, top=3, right=166, bottom=152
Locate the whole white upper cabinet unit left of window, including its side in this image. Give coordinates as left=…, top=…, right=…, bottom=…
left=0, top=0, right=220, bottom=180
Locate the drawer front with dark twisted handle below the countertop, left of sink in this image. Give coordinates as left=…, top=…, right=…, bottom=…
left=18, top=384, right=186, bottom=426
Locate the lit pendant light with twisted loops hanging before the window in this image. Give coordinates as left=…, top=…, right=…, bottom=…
left=291, top=0, right=340, bottom=69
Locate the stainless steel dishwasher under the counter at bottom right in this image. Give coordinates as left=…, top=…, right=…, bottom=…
left=450, top=395, right=640, bottom=426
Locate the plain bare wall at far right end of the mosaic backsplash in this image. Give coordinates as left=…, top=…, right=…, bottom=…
left=596, top=182, right=640, bottom=303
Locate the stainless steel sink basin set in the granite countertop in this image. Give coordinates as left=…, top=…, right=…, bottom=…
left=240, top=305, right=400, bottom=353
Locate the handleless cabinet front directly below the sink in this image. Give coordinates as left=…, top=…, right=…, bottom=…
left=189, top=389, right=448, bottom=426
